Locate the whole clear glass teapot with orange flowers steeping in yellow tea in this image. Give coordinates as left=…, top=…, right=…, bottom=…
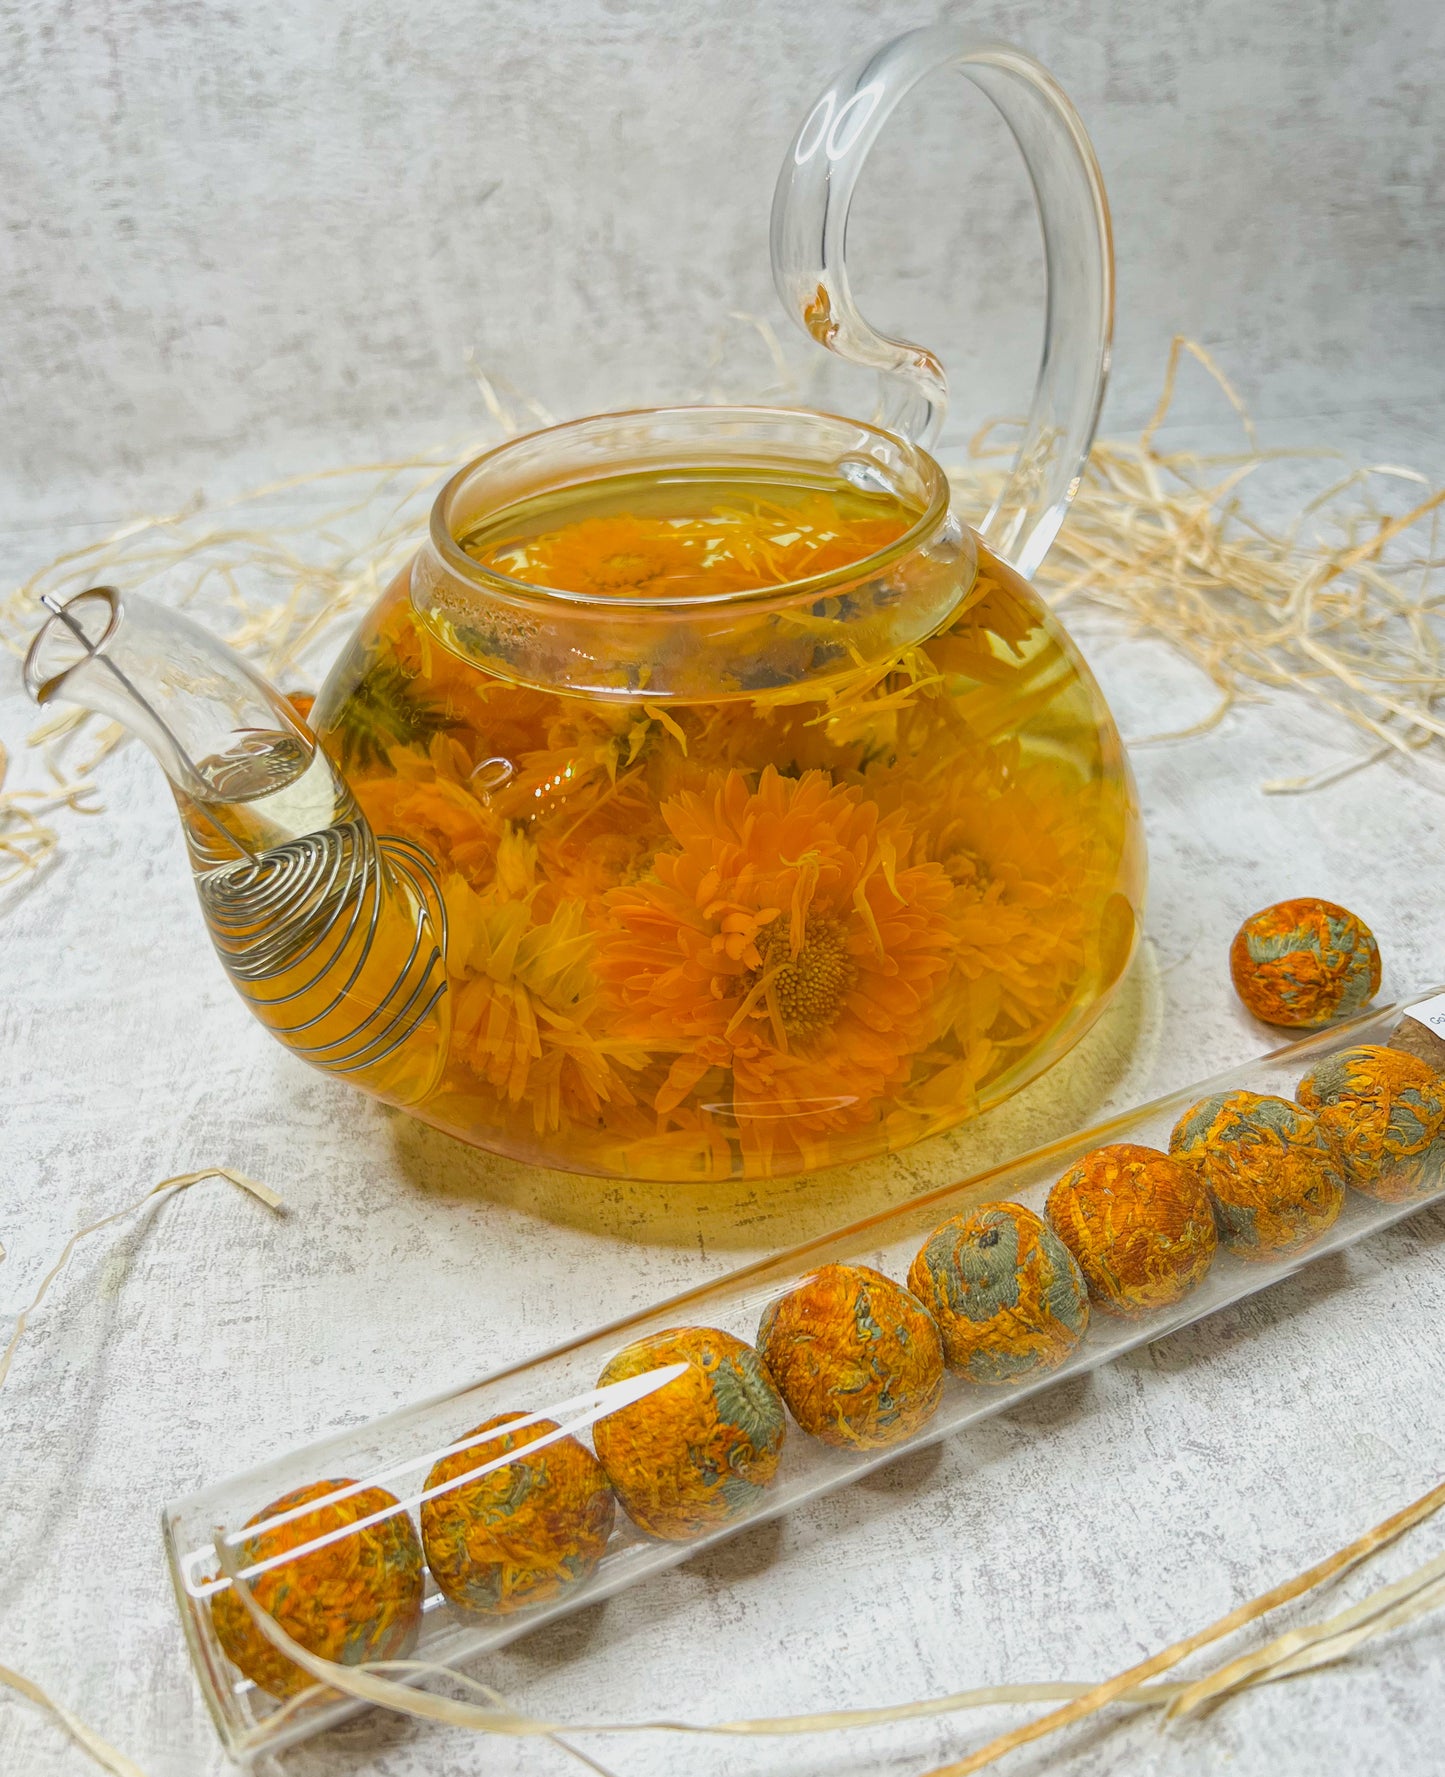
left=27, top=25, right=1143, bottom=1180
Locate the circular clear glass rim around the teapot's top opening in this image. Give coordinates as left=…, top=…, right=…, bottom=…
left=428, top=402, right=951, bottom=615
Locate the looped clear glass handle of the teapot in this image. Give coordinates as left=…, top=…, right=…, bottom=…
left=771, top=25, right=1114, bottom=576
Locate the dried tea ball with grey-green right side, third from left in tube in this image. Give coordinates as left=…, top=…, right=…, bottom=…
left=592, top=1327, right=786, bottom=1542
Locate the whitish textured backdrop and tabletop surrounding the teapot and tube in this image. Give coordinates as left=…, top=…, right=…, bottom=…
left=0, top=0, right=1445, bottom=1777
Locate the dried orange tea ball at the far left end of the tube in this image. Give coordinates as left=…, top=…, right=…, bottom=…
left=212, top=1480, right=421, bottom=1697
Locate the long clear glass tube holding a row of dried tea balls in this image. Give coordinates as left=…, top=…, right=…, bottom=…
left=165, top=997, right=1445, bottom=1759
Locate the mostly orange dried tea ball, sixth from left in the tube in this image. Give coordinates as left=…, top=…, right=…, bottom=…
left=1049, top=1143, right=1219, bottom=1315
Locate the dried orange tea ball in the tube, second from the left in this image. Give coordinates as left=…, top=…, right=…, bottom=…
left=421, top=1413, right=615, bottom=1614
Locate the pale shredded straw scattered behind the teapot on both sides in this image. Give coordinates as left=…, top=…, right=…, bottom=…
left=0, top=338, right=1445, bottom=885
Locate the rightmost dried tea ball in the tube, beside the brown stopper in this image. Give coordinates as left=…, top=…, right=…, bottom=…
left=1294, top=1043, right=1445, bottom=1203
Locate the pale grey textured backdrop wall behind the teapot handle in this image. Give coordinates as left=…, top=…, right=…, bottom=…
left=0, top=0, right=1445, bottom=499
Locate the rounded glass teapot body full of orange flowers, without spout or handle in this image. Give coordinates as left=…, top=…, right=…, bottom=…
left=311, top=409, right=1143, bottom=1180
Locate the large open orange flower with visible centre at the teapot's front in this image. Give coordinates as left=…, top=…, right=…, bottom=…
left=597, top=768, right=954, bottom=1166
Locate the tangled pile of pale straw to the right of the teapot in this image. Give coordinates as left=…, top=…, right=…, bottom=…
left=953, top=336, right=1445, bottom=793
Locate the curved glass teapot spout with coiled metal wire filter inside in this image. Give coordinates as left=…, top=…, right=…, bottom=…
left=25, top=586, right=448, bottom=1104
